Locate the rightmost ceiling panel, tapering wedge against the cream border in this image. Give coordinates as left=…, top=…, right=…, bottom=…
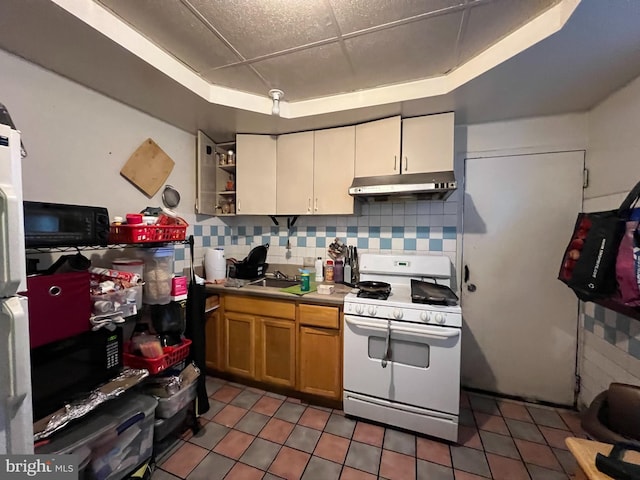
left=457, top=0, right=559, bottom=66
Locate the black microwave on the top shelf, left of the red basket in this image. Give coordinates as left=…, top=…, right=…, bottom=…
left=23, top=201, right=109, bottom=248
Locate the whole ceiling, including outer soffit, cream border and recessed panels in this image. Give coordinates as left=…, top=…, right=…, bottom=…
left=0, top=0, right=640, bottom=141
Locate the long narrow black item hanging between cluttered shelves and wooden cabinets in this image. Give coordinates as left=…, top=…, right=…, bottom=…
left=184, top=235, right=209, bottom=415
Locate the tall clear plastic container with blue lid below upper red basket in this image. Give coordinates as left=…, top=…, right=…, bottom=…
left=140, top=247, right=173, bottom=305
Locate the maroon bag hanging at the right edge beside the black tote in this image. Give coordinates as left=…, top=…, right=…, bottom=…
left=616, top=220, right=640, bottom=307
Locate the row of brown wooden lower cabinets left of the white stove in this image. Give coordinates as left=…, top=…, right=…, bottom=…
left=207, top=295, right=342, bottom=401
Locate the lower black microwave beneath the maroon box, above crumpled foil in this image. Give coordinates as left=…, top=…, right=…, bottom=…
left=31, top=328, right=123, bottom=420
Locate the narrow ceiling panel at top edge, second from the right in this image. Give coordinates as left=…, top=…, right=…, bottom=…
left=329, top=0, right=465, bottom=35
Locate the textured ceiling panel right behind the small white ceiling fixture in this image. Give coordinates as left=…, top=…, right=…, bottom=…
left=253, top=42, right=356, bottom=101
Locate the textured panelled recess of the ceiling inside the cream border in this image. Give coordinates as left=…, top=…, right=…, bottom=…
left=97, top=0, right=559, bottom=102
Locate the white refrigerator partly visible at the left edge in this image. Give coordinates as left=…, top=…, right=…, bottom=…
left=0, top=124, right=33, bottom=454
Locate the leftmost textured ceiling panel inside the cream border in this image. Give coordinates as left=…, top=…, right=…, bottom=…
left=100, top=0, right=238, bottom=72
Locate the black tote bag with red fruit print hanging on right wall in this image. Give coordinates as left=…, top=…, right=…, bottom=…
left=558, top=182, right=640, bottom=302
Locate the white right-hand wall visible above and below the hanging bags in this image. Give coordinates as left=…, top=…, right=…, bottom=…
left=578, top=73, right=640, bottom=407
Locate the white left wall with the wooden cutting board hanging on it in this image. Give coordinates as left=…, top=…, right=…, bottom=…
left=0, top=50, right=195, bottom=217
